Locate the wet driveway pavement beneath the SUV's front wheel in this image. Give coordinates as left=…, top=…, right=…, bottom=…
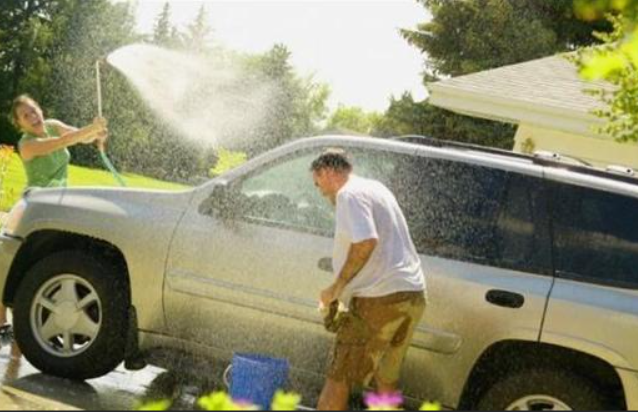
left=0, top=348, right=238, bottom=410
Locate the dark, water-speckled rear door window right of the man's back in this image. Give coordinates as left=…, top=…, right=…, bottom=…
left=355, top=152, right=551, bottom=273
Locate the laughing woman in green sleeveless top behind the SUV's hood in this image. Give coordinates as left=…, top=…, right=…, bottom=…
left=10, top=95, right=108, bottom=187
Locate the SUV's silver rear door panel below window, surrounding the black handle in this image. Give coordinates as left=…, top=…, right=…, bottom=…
left=403, top=256, right=553, bottom=407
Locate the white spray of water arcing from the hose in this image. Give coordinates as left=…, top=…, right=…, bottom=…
left=107, top=44, right=276, bottom=147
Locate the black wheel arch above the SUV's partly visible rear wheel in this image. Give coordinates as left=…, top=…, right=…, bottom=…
left=459, top=341, right=627, bottom=410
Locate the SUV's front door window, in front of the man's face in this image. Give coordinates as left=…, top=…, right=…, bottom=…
left=235, top=151, right=334, bottom=234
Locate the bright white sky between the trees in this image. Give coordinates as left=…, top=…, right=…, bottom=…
left=126, top=0, right=430, bottom=111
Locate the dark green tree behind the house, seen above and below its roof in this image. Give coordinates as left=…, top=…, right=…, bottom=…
left=383, top=0, right=606, bottom=148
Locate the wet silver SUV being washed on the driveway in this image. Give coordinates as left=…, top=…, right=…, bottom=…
left=0, top=137, right=638, bottom=410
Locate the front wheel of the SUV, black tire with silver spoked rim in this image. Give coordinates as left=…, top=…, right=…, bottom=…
left=14, top=251, right=130, bottom=380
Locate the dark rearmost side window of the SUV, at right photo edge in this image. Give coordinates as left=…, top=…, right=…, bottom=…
left=552, top=183, right=638, bottom=287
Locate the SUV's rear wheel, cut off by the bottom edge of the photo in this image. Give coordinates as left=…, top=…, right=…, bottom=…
left=478, top=369, right=614, bottom=411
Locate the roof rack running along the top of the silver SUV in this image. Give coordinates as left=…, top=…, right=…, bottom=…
left=391, top=135, right=638, bottom=184
